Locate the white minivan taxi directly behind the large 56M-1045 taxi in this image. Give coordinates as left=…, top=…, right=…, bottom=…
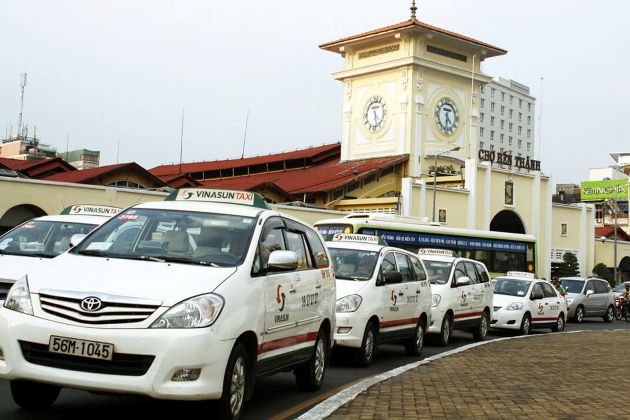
left=326, top=233, right=431, bottom=366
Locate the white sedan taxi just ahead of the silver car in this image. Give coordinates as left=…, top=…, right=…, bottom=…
left=490, top=271, right=568, bottom=335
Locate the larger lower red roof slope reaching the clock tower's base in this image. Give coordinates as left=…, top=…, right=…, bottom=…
left=201, top=155, right=409, bottom=194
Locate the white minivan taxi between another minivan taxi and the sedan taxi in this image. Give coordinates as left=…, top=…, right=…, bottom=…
left=418, top=249, right=492, bottom=346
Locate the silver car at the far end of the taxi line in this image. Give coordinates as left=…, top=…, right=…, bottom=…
left=560, top=277, right=615, bottom=323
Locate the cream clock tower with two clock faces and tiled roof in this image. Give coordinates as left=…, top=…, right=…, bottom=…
left=320, top=2, right=506, bottom=178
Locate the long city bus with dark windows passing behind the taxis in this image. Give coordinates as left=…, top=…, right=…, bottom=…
left=315, top=213, right=537, bottom=277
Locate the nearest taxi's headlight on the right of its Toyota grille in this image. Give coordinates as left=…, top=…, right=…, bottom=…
left=149, top=293, right=223, bottom=328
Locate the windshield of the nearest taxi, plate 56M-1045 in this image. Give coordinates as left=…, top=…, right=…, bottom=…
left=72, top=209, right=256, bottom=267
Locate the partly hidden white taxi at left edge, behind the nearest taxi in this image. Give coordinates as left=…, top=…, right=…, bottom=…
left=0, top=204, right=121, bottom=302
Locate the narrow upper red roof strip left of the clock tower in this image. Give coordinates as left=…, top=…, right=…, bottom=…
left=149, top=143, right=341, bottom=177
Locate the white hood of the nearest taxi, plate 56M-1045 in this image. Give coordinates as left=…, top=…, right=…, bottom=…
left=28, top=254, right=236, bottom=306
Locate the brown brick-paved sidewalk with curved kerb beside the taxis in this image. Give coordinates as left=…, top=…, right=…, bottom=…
left=329, top=331, right=630, bottom=420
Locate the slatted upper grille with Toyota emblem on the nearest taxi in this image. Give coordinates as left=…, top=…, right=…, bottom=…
left=39, top=291, right=160, bottom=325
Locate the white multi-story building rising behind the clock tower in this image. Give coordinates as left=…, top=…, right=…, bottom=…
left=479, top=77, right=536, bottom=170
